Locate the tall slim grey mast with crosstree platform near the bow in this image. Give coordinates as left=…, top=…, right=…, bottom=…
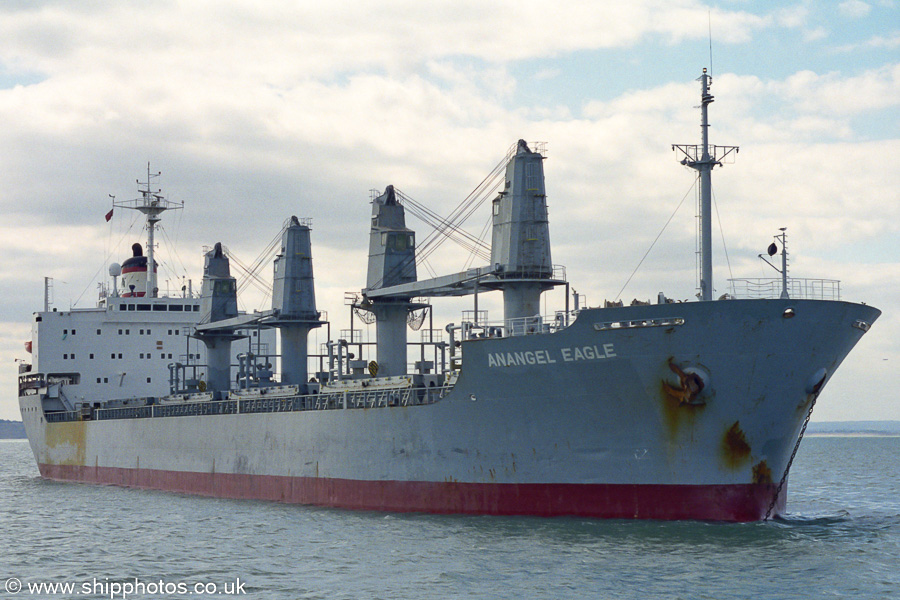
left=672, top=68, right=739, bottom=300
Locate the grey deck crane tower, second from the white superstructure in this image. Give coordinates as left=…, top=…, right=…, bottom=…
left=272, top=217, right=322, bottom=385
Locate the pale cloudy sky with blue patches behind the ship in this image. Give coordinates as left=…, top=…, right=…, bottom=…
left=0, top=0, right=900, bottom=420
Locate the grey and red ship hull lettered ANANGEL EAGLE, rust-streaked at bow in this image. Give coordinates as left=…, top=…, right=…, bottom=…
left=20, top=300, right=880, bottom=521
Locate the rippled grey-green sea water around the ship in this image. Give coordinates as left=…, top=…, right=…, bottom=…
left=0, top=437, right=900, bottom=600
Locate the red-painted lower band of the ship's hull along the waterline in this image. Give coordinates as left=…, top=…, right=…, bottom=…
left=39, top=464, right=784, bottom=522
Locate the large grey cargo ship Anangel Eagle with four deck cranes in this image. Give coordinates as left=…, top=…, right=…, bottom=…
left=19, top=69, right=880, bottom=522
